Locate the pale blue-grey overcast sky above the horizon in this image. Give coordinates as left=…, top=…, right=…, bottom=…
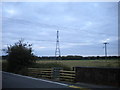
left=2, top=2, right=118, bottom=56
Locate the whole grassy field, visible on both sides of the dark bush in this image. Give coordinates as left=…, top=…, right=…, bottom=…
left=0, top=60, right=120, bottom=70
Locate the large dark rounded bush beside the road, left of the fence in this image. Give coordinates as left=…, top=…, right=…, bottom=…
left=6, top=40, right=35, bottom=72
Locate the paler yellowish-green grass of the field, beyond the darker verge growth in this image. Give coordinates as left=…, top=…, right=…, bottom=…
left=36, top=60, right=120, bottom=69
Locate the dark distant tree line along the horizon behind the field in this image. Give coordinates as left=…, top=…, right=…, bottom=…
left=2, top=55, right=120, bottom=60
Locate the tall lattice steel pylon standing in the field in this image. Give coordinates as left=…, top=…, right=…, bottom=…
left=55, top=30, right=61, bottom=60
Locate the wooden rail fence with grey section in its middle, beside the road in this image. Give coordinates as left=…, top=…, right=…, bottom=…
left=28, top=68, right=75, bottom=82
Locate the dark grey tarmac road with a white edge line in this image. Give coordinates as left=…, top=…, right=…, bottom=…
left=2, top=72, right=70, bottom=88
